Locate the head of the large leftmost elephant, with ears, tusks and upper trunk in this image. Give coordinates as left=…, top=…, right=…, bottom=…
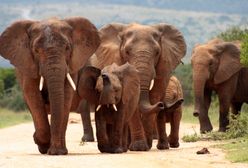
left=0, top=17, right=100, bottom=115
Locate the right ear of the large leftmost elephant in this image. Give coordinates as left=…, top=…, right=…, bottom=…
left=65, top=17, right=100, bottom=73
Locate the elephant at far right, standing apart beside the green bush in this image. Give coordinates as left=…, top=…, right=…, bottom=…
left=191, top=39, right=248, bottom=133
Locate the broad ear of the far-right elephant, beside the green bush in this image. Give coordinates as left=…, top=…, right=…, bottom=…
left=214, top=42, right=242, bottom=84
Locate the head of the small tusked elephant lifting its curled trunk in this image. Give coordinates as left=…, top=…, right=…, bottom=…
left=78, top=63, right=140, bottom=111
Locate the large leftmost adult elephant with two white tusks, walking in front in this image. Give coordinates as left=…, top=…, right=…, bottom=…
left=0, top=17, right=100, bottom=155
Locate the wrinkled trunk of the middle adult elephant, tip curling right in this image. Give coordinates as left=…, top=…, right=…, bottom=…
left=133, top=52, right=164, bottom=113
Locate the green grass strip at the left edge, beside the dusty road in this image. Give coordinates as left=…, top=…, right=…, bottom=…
left=0, top=109, right=32, bottom=128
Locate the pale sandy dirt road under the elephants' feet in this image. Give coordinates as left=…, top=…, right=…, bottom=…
left=0, top=114, right=248, bottom=168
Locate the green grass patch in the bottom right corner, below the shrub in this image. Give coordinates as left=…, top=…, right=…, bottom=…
left=218, top=136, right=248, bottom=163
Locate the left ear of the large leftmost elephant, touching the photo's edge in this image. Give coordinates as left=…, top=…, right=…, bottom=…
left=0, top=20, right=38, bottom=78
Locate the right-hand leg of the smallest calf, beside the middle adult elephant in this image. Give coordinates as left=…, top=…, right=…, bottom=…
left=169, top=106, right=182, bottom=148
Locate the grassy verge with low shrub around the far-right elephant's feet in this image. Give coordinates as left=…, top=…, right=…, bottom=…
left=182, top=105, right=248, bottom=163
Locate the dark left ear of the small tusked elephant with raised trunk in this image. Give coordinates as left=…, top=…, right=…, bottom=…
left=77, top=66, right=101, bottom=103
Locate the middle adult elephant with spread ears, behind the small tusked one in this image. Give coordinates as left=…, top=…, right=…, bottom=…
left=83, top=23, right=186, bottom=150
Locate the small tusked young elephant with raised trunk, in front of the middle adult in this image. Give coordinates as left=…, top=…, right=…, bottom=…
left=78, top=63, right=140, bottom=153
